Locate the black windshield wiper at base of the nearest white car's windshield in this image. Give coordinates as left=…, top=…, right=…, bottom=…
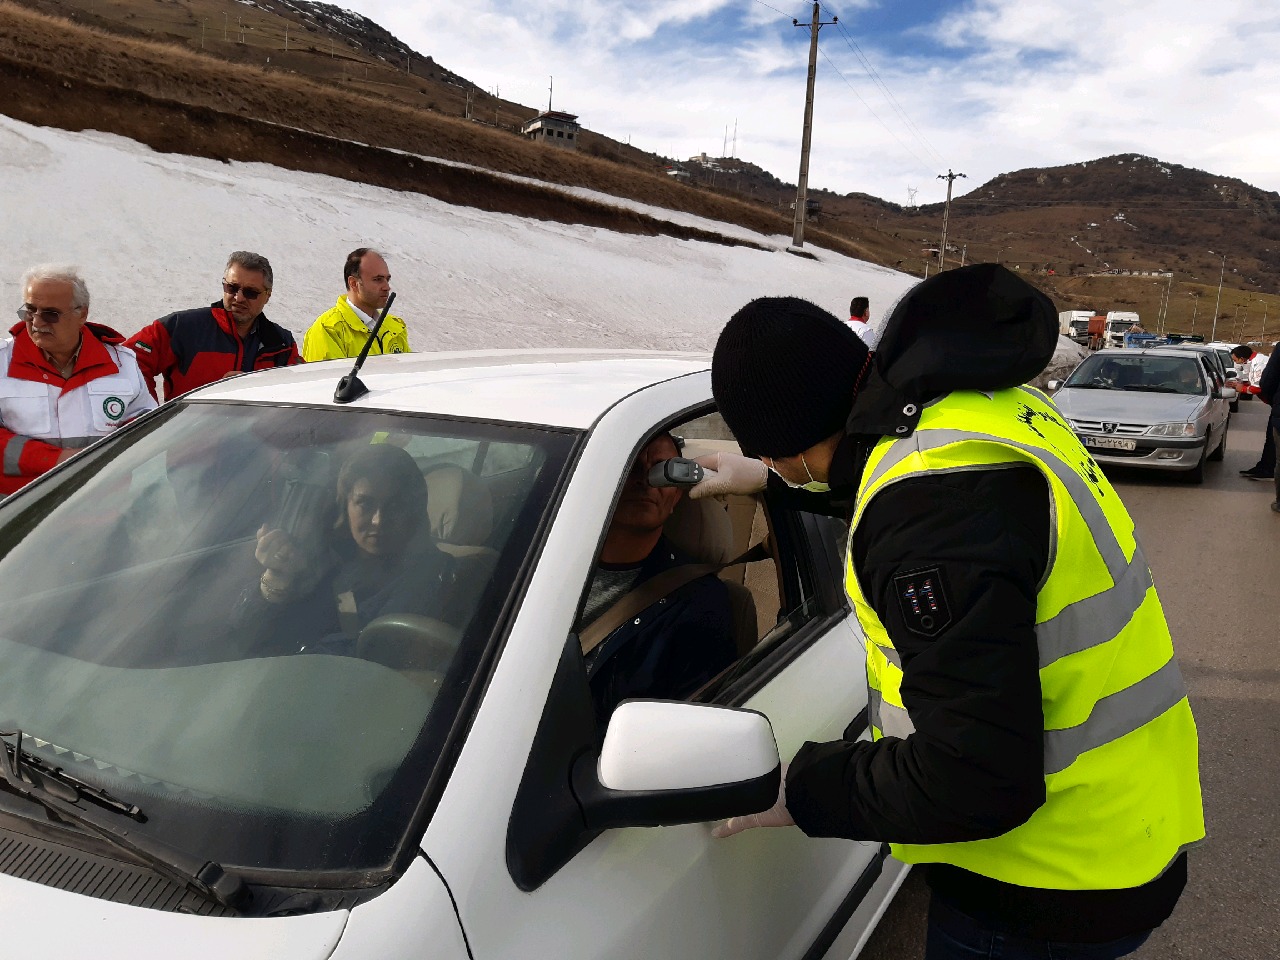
left=0, top=730, right=250, bottom=910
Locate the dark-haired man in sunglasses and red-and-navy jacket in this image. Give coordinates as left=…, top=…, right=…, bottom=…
left=125, top=250, right=302, bottom=399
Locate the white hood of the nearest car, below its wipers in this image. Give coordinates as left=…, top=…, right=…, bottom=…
left=0, top=874, right=348, bottom=960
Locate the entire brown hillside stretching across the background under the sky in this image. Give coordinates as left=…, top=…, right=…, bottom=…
left=0, top=0, right=1280, bottom=338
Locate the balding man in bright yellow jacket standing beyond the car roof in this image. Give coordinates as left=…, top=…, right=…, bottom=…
left=302, top=247, right=412, bottom=364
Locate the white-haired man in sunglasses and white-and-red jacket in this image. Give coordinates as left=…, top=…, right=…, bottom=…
left=0, top=265, right=156, bottom=495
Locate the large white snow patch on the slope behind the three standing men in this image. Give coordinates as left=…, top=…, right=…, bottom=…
left=0, top=116, right=916, bottom=349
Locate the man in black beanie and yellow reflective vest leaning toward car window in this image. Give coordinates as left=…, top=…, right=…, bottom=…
left=691, top=264, right=1204, bottom=960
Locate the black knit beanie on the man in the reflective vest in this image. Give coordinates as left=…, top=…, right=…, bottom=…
left=712, top=297, right=870, bottom=457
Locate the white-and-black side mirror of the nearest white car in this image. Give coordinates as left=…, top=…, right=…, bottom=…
left=572, top=700, right=782, bottom=829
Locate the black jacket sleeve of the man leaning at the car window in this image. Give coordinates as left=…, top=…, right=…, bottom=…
left=786, top=467, right=1052, bottom=844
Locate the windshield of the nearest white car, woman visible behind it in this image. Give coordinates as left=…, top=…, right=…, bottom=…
left=0, top=402, right=575, bottom=870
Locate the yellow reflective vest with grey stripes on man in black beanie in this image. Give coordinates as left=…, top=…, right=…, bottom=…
left=845, top=388, right=1204, bottom=890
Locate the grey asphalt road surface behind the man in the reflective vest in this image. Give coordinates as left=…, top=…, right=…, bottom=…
left=861, top=401, right=1280, bottom=960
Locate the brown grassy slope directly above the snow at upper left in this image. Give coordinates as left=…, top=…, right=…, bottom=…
left=0, top=0, right=880, bottom=256
